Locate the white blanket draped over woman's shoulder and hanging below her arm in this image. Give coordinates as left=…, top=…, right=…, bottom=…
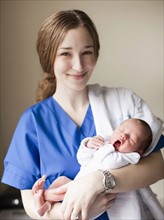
left=85, top=84, right=164, bottom=220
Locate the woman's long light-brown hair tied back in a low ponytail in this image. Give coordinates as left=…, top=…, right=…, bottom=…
left=36, top=10, right=100, bottom=102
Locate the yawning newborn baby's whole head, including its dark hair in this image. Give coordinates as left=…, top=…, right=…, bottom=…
left=111, top=118, right=152, bottom=155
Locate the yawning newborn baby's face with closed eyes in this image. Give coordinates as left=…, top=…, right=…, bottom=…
left=111, top=119, right=143, bottom=153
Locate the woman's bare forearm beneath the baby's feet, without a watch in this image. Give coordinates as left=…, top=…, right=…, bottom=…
left=21, top=190, right=61, bottom=220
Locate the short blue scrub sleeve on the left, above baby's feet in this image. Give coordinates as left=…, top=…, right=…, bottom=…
left=2, top=109, right=40, bottom=190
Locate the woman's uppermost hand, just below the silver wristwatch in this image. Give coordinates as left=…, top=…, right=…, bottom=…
left=61, top=172, right=103, bottom=219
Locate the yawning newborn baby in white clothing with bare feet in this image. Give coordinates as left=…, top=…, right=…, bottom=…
left=32, top=118, right=152, bottom=216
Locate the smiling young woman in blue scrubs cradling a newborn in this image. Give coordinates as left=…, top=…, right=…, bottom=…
left=2, top=10, right=163, bottom=220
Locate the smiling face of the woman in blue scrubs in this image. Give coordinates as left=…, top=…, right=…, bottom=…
left=54, top=27, right=96, bottom=91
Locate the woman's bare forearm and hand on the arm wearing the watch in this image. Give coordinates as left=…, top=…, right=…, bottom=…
left=61, top=151, right=164, bottom=219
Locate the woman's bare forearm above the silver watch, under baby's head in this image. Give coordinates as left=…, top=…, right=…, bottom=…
left=111, top=151, right=164, bottom=192
